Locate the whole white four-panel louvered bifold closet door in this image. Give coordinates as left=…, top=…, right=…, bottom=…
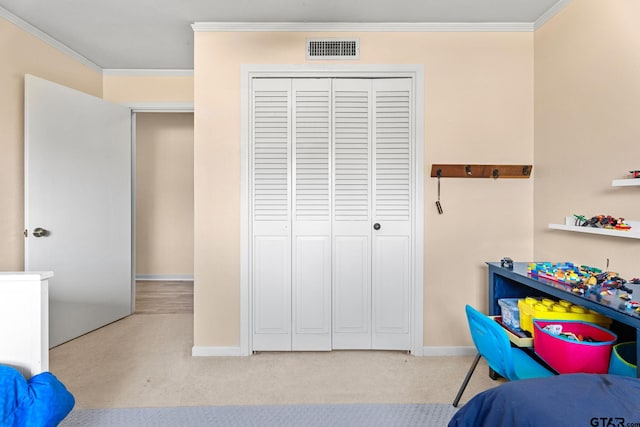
left=250, top=79, right=413, bottom=351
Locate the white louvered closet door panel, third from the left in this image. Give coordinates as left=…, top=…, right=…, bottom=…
left=332, top=79, right=372, bottom=349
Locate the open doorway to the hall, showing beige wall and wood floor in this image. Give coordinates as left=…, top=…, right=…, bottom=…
left=134, top=112, right=193, bottom=314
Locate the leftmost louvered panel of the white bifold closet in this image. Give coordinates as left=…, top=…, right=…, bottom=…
left=250, top=79, right=291, bottom=351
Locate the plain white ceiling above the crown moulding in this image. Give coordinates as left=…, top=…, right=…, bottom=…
left=0, top=0, right=567, bottom=70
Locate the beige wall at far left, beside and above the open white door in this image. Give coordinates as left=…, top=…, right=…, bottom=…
left=0, top=18, right=102, bottom=271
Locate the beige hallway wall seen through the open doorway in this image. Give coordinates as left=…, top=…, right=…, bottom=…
left=135, top=113, right=193, bottom=277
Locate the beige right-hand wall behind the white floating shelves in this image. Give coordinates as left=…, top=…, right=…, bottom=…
left=534, top=0, right=640, bottom=279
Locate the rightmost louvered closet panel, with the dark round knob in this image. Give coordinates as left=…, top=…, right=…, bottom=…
left=372, top=79, right=413, bottom=350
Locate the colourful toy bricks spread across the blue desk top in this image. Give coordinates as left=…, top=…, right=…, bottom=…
left=527, top=262, right=640, bottom=301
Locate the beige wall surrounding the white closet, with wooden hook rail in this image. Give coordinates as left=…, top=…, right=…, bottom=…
left=194, top=32, right=535, bottom=346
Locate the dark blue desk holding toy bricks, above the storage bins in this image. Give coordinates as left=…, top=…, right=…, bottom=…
left=487, top=262, right=640, bottom=378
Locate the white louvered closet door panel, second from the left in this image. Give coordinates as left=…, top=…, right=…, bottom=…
left=291, top=79, right=332, bottom=351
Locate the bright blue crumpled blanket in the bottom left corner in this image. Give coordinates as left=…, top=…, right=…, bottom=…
left=0, top=365, right=75, bottom=427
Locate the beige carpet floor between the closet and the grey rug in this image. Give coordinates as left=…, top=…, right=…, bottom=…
left=50, top=314, right=499, bottom=408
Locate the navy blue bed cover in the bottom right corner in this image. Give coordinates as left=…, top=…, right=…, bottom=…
left=449, top=374, right=640, bottom=427
